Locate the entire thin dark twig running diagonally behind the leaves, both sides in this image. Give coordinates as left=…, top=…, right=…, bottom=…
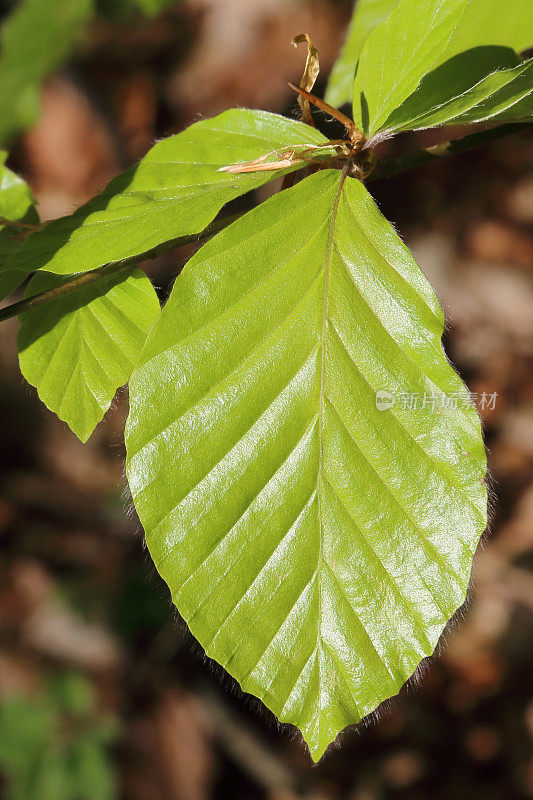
left=0, top=122, right=533, bottom=322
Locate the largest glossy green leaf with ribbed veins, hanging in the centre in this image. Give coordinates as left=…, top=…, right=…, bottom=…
left=126, top=170, right=486, bottom=759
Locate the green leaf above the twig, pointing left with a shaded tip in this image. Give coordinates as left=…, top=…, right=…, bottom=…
left=9, top=109, right=328, bottom=274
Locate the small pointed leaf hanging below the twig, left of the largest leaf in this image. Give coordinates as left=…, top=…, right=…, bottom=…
left=18, top=269, right=159, bottom=442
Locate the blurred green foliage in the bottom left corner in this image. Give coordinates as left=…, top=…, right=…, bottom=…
left=0, top=674, right=117, bottom=800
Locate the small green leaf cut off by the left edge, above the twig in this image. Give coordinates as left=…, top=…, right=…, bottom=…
left=0, top=150, right=39, bottom=300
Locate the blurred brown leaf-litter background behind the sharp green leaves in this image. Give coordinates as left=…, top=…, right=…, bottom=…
left=0, top=0, right=533, bottom=800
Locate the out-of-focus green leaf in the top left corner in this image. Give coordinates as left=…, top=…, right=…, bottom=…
left=0, top=0, right=92, bottom=144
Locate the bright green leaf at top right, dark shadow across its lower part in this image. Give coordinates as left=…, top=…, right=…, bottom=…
left=353, top=0, right=533, bottom=136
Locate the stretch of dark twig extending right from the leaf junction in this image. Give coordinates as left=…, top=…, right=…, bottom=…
left=367, top=122, right=533, bottom=182
